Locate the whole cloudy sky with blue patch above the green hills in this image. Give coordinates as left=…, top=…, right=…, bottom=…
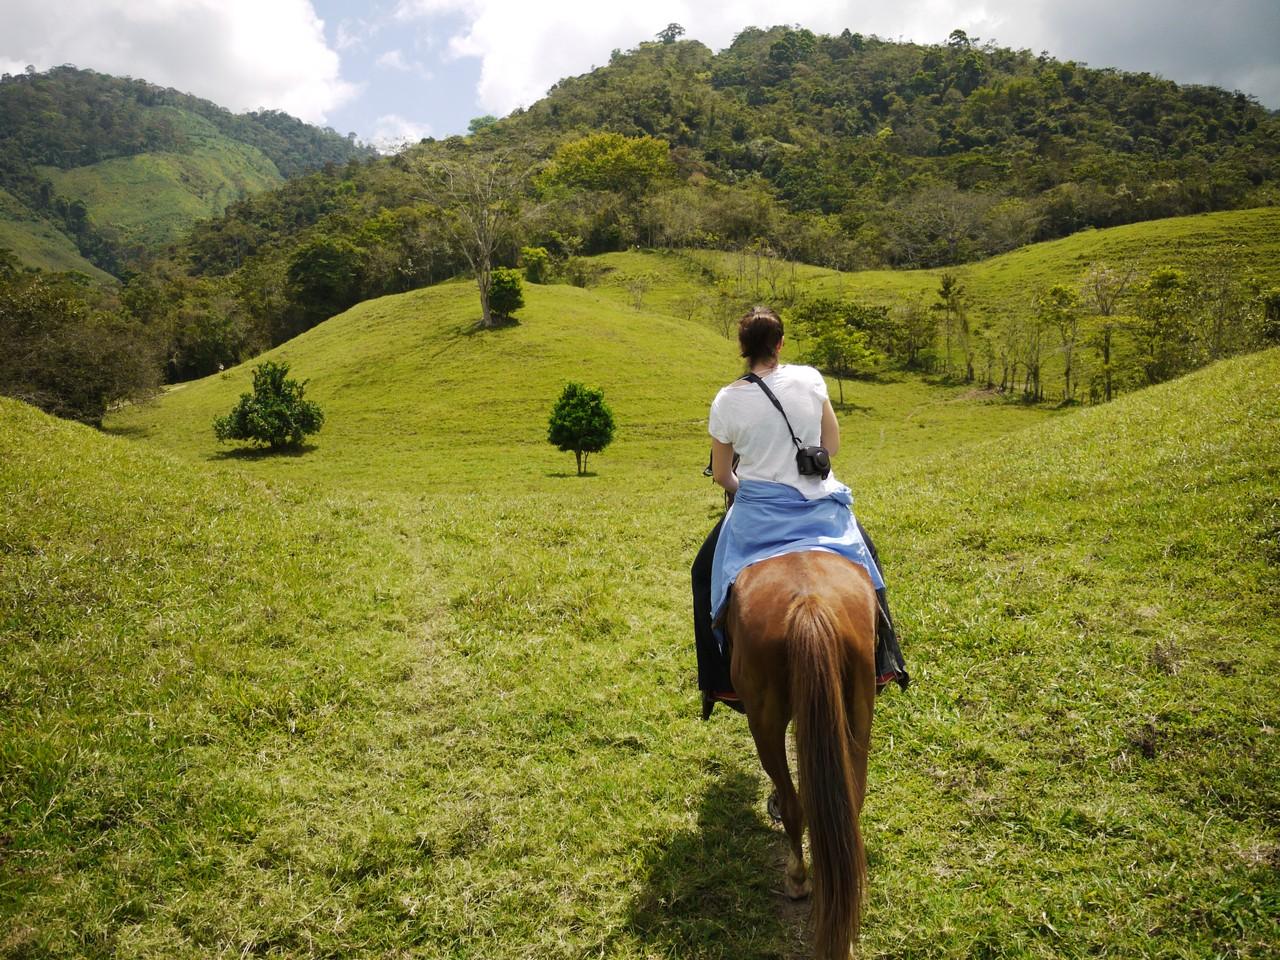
left=0, top=0, right=1280, bottom=148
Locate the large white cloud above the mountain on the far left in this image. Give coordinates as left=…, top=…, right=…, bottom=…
left=0, top=0, right=358, bottom=123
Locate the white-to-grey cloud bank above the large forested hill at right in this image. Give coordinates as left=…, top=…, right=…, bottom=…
left=394, top=0, right=1280, bottom=114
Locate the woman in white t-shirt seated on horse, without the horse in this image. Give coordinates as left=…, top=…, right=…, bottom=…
left=691, top=307, right=909, bottom=719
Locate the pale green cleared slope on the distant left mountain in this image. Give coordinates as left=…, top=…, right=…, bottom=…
left=40, top=108, right=283, bottom=246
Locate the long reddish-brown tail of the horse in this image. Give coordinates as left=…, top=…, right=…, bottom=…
left=787, top=594, right=867, bottom=960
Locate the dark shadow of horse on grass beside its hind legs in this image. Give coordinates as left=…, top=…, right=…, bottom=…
left=611, top=769, right=808, bottom=960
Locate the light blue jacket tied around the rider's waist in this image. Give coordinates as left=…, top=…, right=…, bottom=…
left=712, top=480, right=884, bottom=645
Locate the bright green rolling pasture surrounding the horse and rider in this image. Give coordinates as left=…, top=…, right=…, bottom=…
left=0, top=261, right=1280, bottom=959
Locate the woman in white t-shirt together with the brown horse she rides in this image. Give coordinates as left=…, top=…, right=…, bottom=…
left=692, top=307, right=908, bottom=960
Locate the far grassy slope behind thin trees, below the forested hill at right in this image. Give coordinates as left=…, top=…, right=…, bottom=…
left=583, top=207, right=1280, bottom=401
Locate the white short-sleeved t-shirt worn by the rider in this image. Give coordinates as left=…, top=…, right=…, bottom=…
left=707, top=364, right=841, bottom=500
